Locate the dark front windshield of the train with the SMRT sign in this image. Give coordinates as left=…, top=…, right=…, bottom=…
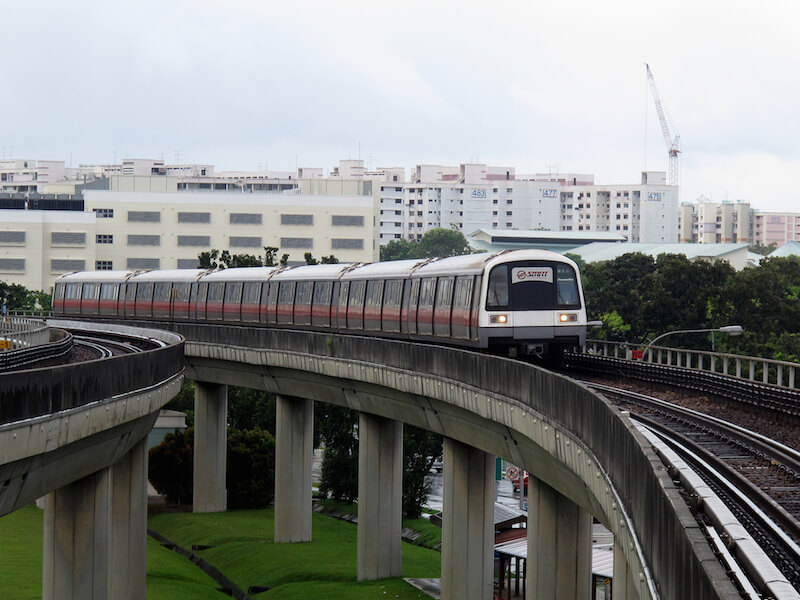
left=486, top=261, right=581, bottom=310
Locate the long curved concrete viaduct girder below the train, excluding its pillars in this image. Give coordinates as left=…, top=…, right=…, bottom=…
left=128, top=322, right=737, bottom=600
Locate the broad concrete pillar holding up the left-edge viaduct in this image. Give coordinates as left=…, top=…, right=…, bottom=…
left=42, top=438, right=147, bottom=600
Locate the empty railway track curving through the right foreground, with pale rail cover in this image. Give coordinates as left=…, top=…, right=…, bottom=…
left=585, top=382, right=800, bottom=598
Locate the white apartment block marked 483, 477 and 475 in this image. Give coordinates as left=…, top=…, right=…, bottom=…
left=376, top=164, right=678, bottom=245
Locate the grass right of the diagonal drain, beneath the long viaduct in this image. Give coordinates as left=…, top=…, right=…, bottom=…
left=150, top=510, right=441, bottom=599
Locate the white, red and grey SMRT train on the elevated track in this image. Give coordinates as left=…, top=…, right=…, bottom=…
left=53, top=250, right=587, bottom=358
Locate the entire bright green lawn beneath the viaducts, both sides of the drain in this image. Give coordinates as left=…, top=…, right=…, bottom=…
left=0, top=506, right=441, bottom=600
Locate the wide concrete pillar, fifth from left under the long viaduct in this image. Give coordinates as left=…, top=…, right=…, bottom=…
left=527, top=477, right=592, bottom=600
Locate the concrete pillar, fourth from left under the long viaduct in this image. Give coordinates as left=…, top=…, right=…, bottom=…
left=442, top=438, right=495, bottom=600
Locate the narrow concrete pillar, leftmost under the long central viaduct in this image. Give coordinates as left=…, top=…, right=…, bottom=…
left=192, top=381, right=228, bottom=512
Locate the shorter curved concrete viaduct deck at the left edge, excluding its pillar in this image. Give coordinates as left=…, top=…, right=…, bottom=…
left=0, top=321, right=184, bottom=516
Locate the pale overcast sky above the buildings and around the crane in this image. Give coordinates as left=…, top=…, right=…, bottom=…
left=0, top=0, right=800, bottom=212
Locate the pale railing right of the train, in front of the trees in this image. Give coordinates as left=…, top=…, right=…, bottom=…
left=582, top=340, right=800, bottom=390
